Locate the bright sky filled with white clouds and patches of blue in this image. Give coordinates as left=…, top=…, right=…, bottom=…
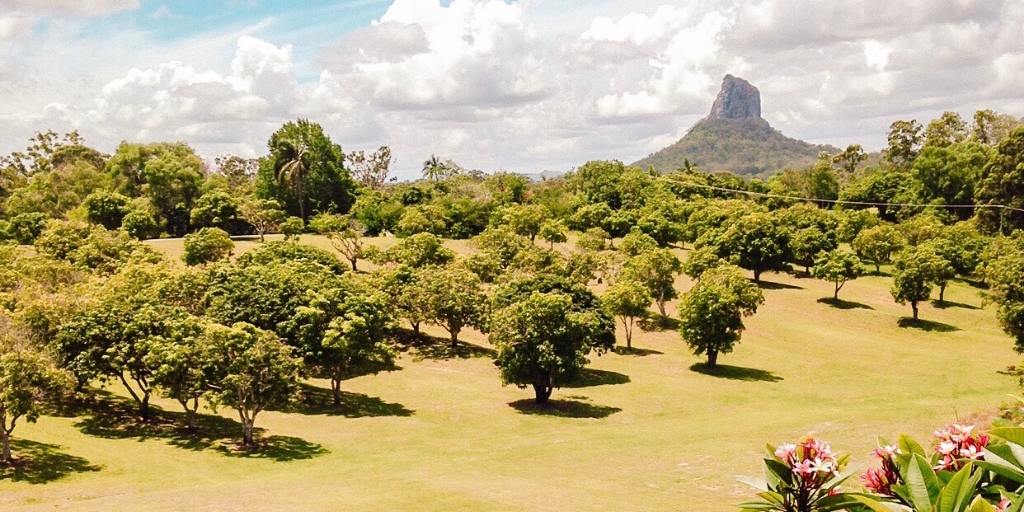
left=0, top=0, right=1024, bottom=178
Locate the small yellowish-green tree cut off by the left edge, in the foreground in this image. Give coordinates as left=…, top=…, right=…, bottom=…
left=0, top=333, right=71, bottom=465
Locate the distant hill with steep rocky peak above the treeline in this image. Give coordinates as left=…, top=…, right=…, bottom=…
left=633, top=75, right=839, bottom=174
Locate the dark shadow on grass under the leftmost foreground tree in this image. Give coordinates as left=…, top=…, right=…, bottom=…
left=0, top=439, right=100, bottom=484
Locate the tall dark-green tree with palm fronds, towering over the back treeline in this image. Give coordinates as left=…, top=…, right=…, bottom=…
left=256, top=119, right=354, bottom=220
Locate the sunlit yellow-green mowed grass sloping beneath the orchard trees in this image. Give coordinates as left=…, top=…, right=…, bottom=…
left=0, top=237, right=1017, bottom=511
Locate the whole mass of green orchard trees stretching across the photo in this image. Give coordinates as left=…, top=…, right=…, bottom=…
left=0, top=111, right=1024, bottom=463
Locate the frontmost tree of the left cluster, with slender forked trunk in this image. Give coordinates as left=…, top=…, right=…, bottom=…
left=203, top=323, right=302, bottom=447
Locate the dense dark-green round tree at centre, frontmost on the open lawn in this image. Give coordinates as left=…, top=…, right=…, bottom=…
left=489, top=292, right=615, bottom=403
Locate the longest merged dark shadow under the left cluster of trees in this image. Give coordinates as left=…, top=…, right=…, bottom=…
left=75, top=392, right=327, bottom=462
